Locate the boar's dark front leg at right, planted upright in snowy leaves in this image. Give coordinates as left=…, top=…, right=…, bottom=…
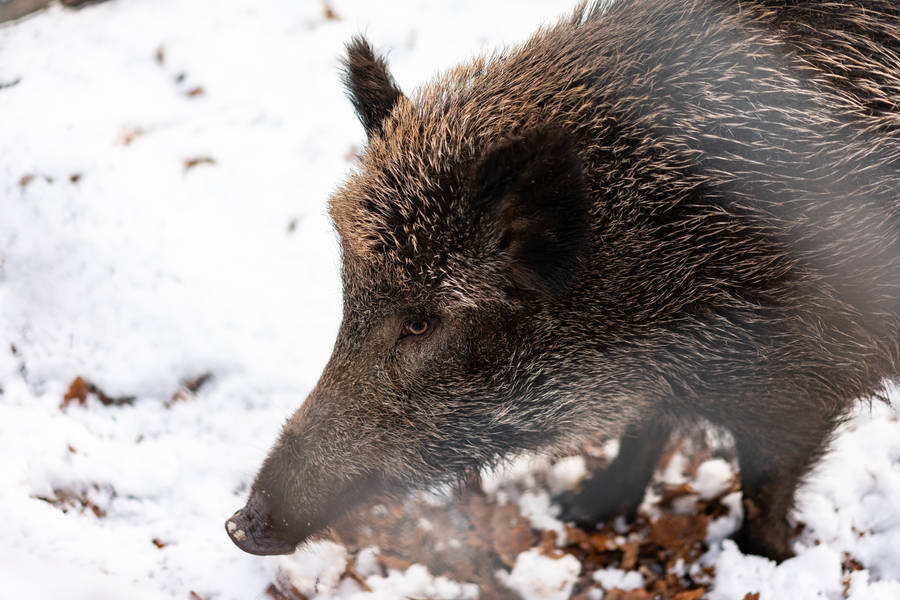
left=730, top=409, right=839, bottom=562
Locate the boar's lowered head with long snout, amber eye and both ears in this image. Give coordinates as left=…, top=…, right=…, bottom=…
left=226, top=39, right=632, bottom=554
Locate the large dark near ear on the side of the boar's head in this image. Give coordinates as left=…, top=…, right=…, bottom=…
left=472, top=127, right=590, bottom=296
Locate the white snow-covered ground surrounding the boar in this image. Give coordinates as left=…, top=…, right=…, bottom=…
left=0, top=0, right=900, bottom=600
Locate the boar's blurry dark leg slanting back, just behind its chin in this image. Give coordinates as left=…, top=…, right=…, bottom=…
left=557, top=419, right=671, bottom=527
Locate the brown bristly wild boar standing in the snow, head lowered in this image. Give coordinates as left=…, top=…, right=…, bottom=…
left=227, top=0, right=900, bottom=559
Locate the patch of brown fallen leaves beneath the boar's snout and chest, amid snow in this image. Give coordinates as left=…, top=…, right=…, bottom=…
left=310, top=436, right=731, bottom=600
